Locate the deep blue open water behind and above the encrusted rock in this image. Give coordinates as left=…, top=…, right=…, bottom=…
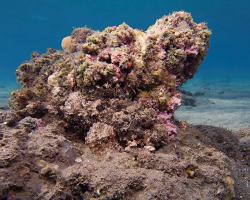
left=0, top=0, right=250, bottom=82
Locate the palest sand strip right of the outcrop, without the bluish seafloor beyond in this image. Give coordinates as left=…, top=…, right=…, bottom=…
left=175, top=99, right=250, bottom=130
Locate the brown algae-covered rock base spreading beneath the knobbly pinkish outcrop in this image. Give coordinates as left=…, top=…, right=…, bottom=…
left=0, top=112, right=250, bottom=200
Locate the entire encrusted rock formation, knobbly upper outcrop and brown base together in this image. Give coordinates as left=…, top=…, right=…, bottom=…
left=0, top=12, right=249, bottom=200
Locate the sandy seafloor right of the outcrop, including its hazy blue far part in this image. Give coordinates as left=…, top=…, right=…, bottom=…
left=176, top=78, right=250, bottom=130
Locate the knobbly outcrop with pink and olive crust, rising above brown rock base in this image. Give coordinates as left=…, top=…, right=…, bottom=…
left=10, top=12, right=210, bottom=151
